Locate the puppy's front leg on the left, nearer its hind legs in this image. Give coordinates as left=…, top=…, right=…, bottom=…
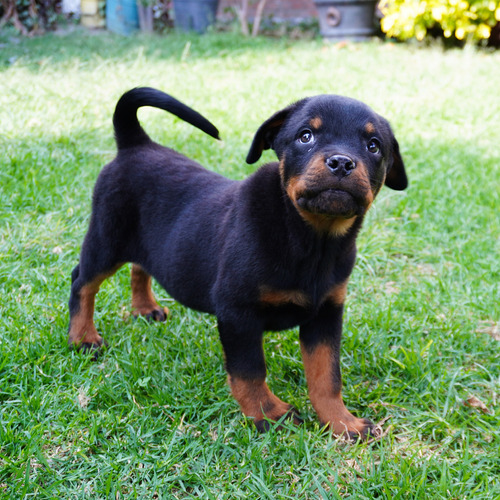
left=219, top=318, right=300, bottom=432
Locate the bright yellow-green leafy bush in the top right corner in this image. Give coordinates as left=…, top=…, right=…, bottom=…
left=381, top=0, right=500, bottom=42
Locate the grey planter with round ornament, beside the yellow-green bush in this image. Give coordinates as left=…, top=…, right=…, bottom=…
left=314, top=0, right=378, bottom=40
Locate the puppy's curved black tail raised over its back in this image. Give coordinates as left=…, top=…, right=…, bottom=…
left=113, top=87, right=219, bottom=149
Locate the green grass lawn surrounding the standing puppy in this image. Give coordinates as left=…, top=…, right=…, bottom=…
left=0, top=30, right=500, bottom=500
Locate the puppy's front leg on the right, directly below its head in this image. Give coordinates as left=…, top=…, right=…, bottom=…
left=300, top=303, right=376, bottom=439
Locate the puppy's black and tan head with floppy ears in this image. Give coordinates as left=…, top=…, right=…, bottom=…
left=247, top=95, right=408, bottom=235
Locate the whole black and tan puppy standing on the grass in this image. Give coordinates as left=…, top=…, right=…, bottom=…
left=69, top=88, right=407, bottom=438
